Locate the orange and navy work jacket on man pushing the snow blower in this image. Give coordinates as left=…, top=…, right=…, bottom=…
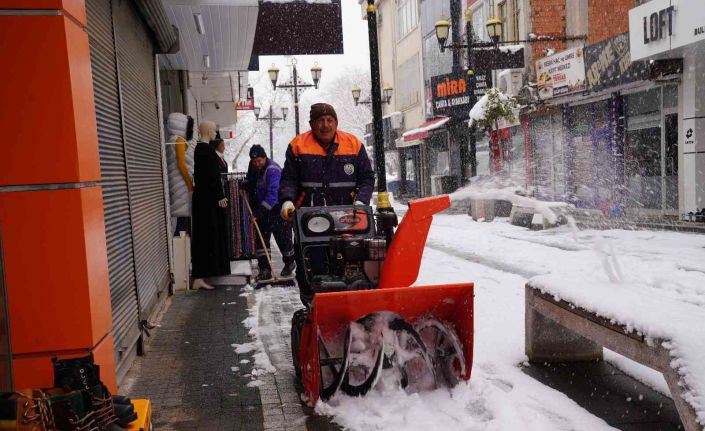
left=279, top=130, right=375, bottom=206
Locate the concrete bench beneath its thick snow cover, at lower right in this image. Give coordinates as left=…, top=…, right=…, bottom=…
left=525, top=282, right=703, bottom=431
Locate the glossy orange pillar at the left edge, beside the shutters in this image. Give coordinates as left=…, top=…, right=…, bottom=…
left=0, top=0, right=116, bottom=391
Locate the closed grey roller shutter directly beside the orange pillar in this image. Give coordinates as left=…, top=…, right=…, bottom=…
left=86, top=0, right=140, bottom=374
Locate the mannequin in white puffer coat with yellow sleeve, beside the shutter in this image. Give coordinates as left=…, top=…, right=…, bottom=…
left=166, top=112, right=195, bottom=236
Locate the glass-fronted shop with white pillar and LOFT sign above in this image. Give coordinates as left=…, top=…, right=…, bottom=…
left=625, top=0, right=705, bottom=219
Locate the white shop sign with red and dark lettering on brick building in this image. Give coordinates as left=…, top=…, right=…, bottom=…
left=536, top=47, right=586, bottom=99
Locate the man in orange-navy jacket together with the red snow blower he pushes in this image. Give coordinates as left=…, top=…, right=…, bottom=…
left=279, top=103, right=473, bottom=404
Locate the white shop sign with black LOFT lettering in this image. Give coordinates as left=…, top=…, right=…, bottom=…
left=629, top=0, right=705, bottom=61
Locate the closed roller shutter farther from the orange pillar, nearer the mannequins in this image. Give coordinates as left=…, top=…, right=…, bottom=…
left=113, top=0, right=169, bottom=319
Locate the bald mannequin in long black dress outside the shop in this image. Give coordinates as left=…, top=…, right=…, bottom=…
left=191, top=121, right=230, bottom=290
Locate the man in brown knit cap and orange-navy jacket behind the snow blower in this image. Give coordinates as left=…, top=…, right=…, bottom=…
left=279, top=103, right=375, bottom=305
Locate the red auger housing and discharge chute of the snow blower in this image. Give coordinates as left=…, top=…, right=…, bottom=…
left=298, top=195, right=474, bottom=405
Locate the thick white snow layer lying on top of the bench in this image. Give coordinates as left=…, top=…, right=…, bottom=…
left=530, top=274, right=705, bottom=424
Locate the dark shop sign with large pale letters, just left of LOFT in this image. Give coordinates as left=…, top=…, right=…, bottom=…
left=585, top=33, right=649, bottom=91
